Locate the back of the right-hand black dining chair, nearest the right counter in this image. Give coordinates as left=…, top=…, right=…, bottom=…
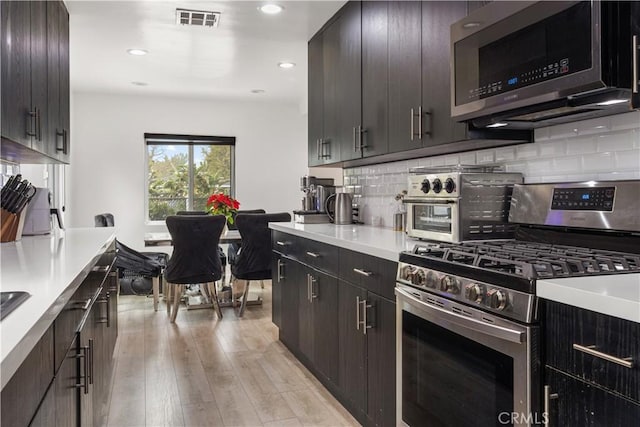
left=231, top=212, right=291, bottom=280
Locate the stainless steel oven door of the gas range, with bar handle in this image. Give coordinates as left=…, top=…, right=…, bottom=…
left=396, top=284, right=544, bottom=427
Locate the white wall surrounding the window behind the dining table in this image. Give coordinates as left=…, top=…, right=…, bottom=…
left=66, top=92, right=308, bottom=250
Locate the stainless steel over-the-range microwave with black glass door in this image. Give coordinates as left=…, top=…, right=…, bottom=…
left=451, top=1, right=640, bottom=129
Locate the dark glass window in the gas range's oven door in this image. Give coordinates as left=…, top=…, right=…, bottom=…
left=402, top=311, right=513, bottom=427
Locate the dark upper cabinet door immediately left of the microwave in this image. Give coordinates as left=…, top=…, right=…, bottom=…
left=421, top=1, right=467, bottom=146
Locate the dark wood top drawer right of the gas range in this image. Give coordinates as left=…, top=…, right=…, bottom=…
left=545, top=301, right=640, bottom=402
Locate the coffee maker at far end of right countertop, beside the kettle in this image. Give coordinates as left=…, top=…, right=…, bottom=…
left=293, top=175, right=336, bottom=224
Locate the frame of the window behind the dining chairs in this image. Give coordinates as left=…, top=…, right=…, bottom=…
left=144, top=133, right=236, bottom=225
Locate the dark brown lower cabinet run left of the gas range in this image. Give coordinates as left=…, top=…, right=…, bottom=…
left=272, top=232, right=397, bottom=427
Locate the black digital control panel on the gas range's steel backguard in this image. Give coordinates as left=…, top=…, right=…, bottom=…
left=551, top=187, right=616, bottom=212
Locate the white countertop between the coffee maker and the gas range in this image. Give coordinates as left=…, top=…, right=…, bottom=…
left=269, top=222, right=420, bottom=262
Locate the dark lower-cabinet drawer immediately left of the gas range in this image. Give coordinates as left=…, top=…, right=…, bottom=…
left=339, top=249, right=398, bottom=300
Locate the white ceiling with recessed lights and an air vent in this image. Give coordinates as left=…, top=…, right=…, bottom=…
left=65, top=0, right=345, bottom=102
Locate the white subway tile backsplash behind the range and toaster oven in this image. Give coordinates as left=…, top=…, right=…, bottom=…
left=343, top=111, right=640, bottom=227
